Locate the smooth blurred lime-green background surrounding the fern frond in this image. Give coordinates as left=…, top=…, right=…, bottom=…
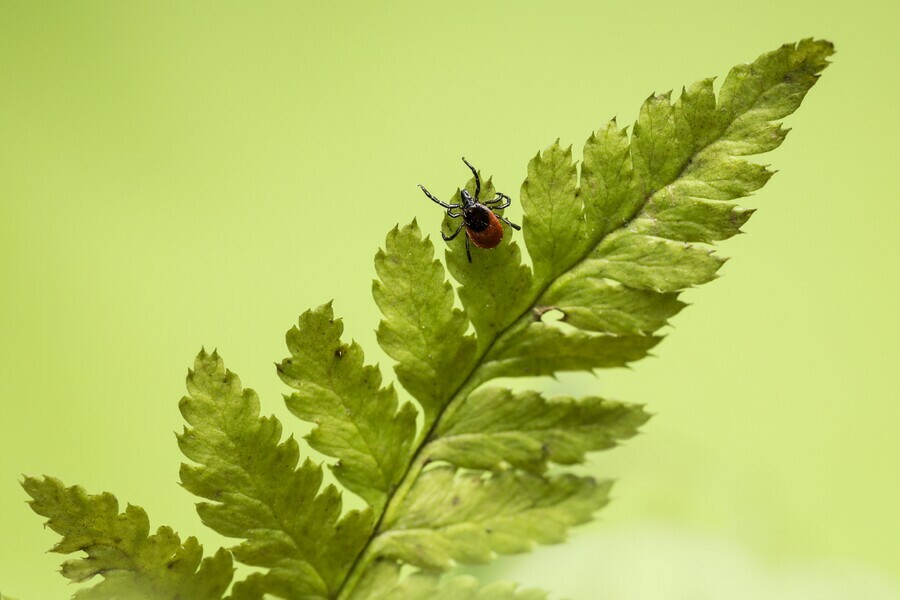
left=0, top=0, right=900, bottom=600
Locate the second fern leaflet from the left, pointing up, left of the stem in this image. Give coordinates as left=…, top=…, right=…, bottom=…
left=178, top=352, right=373, bottom=599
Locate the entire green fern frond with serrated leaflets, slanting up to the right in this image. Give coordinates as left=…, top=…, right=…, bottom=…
left=17, top=40, right=833, bottom=600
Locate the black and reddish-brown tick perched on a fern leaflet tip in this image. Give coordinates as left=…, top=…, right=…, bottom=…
left=419, top=157, right=522, bottom=262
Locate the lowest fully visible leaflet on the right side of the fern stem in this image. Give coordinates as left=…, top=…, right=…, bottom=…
left=374, top=466, right=611, bottom=571
